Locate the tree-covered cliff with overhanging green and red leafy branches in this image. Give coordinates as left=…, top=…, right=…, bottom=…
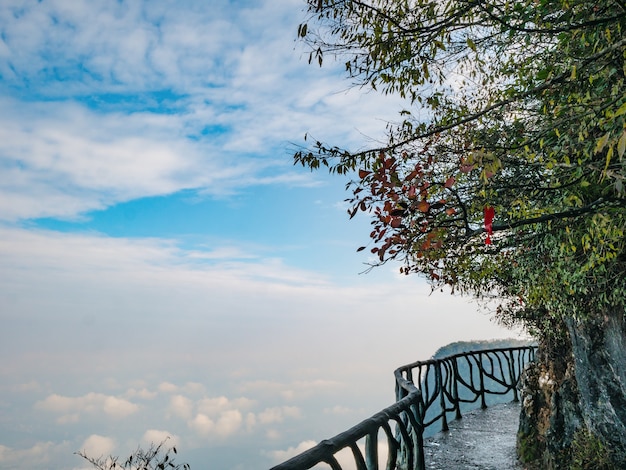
left=295, top=0, right=626, bottom=468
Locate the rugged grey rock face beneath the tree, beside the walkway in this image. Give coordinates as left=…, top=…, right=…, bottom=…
left=518, top=311, right=626, bottom=470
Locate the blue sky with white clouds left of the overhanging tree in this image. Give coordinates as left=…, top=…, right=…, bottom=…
left=0, top=0, right=519, bottom=470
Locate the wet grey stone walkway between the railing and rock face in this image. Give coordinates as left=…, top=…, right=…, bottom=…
left=424, top=403, right=524, bottom=470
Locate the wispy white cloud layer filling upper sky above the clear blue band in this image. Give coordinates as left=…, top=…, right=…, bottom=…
left=0, top=0, right=404, bottom=221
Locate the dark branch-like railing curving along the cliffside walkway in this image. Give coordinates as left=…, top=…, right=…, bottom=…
left=271, top=346, right=536, bottom=470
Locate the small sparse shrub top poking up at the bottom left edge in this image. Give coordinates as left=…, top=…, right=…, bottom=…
left=76, top=439, right=191, bottom=470
